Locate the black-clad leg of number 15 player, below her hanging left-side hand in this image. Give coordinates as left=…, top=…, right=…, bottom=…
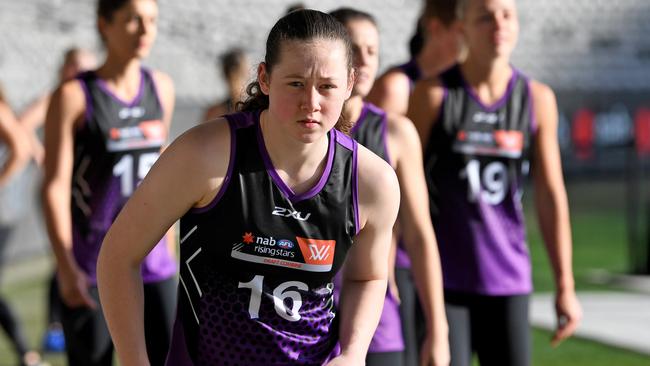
left=61, top=287, right=113, bottom=366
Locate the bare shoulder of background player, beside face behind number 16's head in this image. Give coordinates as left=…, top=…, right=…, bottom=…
left=366, top=70, right=411, bottom=116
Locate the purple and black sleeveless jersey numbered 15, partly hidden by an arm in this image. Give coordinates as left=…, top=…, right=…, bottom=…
left=71, top=69, right=176, bottom=283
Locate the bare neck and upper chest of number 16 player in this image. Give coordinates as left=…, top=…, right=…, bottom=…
left=260, top=109, right=329, bottom=194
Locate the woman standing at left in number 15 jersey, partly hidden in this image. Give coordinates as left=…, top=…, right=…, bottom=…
left=43, top=0, right=176, bottom=366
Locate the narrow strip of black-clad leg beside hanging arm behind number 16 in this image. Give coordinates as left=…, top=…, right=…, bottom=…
left=395, top=268, right=419, bottom=366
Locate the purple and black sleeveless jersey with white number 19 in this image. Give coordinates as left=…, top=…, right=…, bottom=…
left=424, top=66, right=536, bottom=295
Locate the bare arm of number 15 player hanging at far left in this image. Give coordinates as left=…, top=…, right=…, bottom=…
left=42, top=81, right=96, bottom=307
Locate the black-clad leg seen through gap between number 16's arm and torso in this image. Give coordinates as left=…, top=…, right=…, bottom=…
left=144, top=277, right=177, bottom=366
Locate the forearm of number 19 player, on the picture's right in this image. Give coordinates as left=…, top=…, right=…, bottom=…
left=535, top=189, right=574, bottom=291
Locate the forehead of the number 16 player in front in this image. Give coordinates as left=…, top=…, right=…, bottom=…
left=272, top=39, right=348, bottom=78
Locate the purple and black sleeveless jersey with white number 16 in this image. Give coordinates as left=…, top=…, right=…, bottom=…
left=167, top=111, right=359, bottom=366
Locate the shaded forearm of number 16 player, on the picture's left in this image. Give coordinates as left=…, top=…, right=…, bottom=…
left=97, top=243, right=149, bottom=366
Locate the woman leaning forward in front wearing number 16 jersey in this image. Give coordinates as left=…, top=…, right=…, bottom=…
left=98, top=10, right=399, bottom=366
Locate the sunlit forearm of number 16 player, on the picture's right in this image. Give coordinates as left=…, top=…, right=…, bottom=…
left=339, top=279, right=386, bottom=361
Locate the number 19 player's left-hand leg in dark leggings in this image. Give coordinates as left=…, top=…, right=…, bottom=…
left=445, top=290, right=472, bottom=366
